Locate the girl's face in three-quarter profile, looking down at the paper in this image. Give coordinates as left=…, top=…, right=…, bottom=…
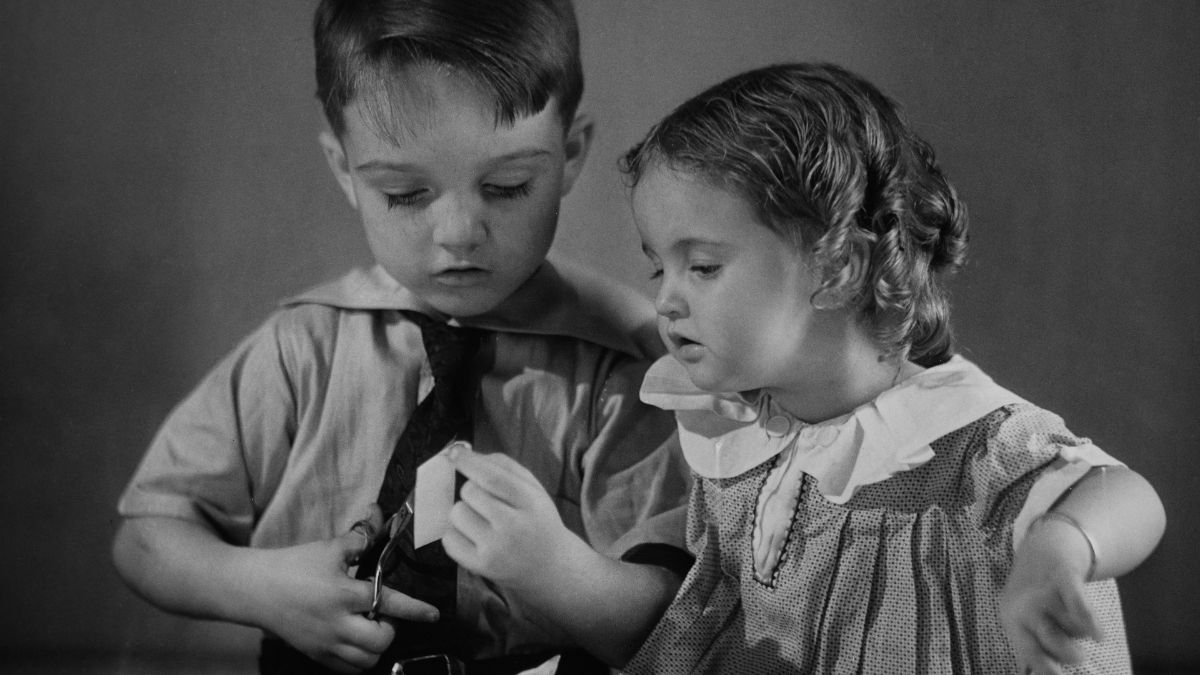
left=632, top=165, right=844, bottom=398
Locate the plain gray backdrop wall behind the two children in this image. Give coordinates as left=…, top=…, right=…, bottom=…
left=0, top=0, right=1200, bottom=671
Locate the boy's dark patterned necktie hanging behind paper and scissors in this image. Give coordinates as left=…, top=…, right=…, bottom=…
left=358, top=311, right=485, bottom=655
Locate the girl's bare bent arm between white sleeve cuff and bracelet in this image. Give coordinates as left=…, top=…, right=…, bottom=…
left=1051, top=467, right=1166, bottom=579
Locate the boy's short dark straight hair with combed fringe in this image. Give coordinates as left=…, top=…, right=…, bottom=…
left=313, top=0, right=583, bottom=136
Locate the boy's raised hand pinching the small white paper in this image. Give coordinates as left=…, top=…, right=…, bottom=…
left=442, top=444, right=572, bottom=587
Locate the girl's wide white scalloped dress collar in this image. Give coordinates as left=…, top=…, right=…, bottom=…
left=641, top=356, right=1021, bottom=503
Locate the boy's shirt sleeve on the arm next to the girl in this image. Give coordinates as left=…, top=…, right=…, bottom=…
left=580, top=357, right=691, bottom=562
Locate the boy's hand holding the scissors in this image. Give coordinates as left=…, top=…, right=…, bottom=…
left=253, top=507, right=438, bottom=673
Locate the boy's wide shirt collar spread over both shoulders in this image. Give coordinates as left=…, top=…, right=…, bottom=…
left=282, top=253, right=664, bottom=358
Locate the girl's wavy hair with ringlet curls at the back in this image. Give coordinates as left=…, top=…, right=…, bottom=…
left=622, top=64, right=967, bottom=366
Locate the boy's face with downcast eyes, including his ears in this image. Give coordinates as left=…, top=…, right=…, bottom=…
left=320, top=68, right=592, bottom=317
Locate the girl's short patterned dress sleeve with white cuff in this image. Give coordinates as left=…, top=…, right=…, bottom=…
left=971, top=402, right=1121, bottom=549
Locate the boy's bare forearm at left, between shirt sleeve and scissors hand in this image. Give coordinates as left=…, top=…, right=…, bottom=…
left=113, top=518, right=271, bottom=626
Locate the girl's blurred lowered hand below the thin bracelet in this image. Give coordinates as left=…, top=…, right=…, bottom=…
left=1000, top=511, right=1103, bottom=675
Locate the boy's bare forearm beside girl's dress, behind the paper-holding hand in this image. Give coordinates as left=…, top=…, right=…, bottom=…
left=523, top=538, right=680, bottom=667
